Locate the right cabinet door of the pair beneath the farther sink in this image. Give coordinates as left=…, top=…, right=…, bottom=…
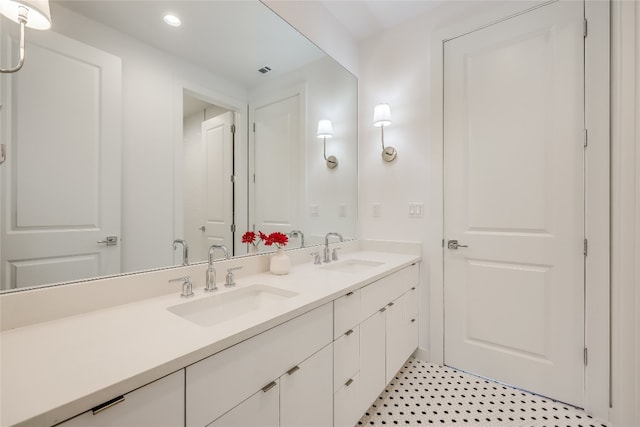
left=385, top=294, right=409, bottom=385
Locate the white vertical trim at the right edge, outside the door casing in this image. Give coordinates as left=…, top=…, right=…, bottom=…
left=611, top=1, right=640, bottom=426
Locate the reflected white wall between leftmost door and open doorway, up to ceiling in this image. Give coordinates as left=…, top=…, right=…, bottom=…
left=53, top=7, right=247, bottom=271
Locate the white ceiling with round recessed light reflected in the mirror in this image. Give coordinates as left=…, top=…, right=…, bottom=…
left=51, top=0, right=325, bottom=89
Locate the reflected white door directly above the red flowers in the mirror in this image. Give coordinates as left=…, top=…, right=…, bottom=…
left=250, top=94, right=303, bottom=239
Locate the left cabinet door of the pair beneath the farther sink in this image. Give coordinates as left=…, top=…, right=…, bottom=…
left=360, top=307, right=387, bottom=414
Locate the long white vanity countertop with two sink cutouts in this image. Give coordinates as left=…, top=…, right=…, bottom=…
left=0, top=251, right=420, bottom=427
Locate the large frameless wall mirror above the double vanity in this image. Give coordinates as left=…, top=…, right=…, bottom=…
left=0, top=0, right=357, bottom=291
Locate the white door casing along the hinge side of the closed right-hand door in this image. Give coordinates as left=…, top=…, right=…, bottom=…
left=584, top=1, right=611, bottom=419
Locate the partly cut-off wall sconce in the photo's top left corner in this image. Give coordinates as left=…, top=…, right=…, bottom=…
left=0, top=0, right=51, bottom=73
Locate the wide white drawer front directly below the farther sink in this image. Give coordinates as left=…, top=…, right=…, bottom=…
left=360, top=263, right=420, bottom=321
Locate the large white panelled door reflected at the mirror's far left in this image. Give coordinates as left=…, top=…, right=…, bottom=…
left=0, top=22, right=121, bottom=289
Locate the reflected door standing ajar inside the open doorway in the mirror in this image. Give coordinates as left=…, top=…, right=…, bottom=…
left=201, top=112, right=234, bottom=256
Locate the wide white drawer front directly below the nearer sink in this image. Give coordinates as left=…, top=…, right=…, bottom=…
left=186, top=303, right=333, bottom=427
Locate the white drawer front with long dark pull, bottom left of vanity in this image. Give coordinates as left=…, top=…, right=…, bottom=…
left=58, top=369, right=184, bottom=427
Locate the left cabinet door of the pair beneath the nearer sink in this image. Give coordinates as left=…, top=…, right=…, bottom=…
left=208, top=380, right=280, bottom=427
